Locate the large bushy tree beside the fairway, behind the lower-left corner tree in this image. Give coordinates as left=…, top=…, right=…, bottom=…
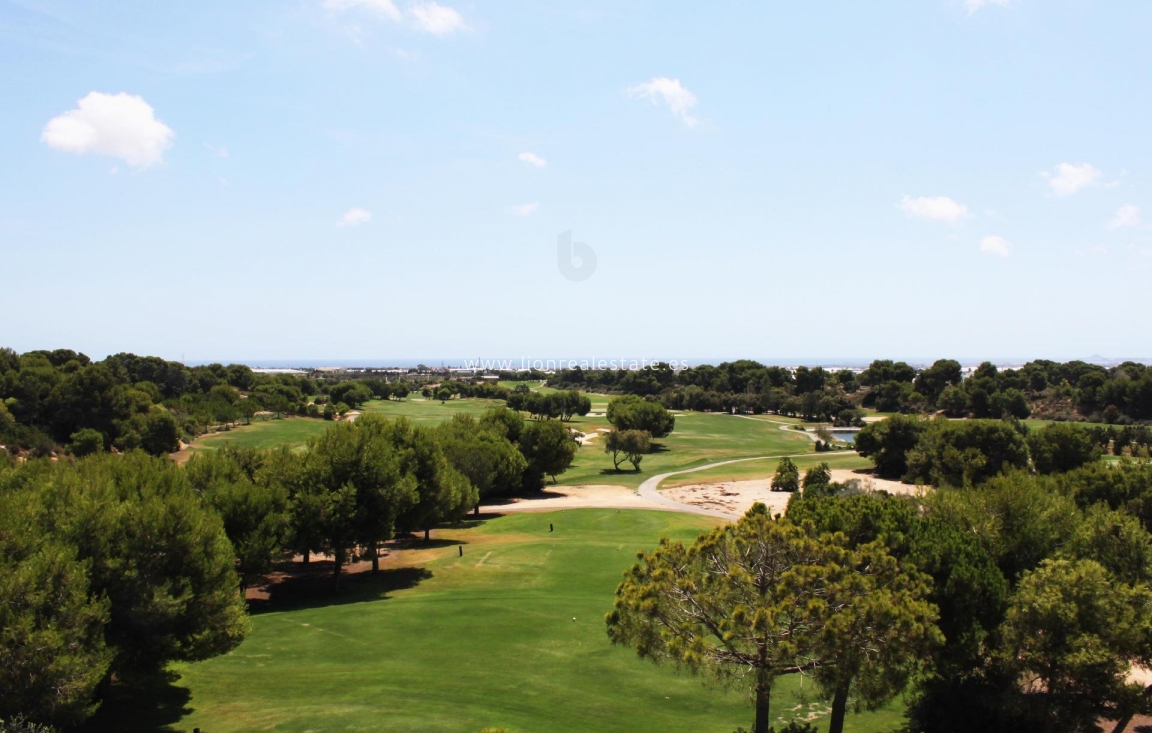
left=24, top=452, right=248, bottom=674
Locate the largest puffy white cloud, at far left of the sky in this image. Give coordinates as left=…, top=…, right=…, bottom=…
left=40, top=92, right=176, bottom=168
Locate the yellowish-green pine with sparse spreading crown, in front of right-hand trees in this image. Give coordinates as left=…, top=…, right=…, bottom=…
left=606, top=504, right=931, bottom=733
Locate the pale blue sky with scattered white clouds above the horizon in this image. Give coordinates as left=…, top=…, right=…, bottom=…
left=0, top=0, right=1152, bottom=362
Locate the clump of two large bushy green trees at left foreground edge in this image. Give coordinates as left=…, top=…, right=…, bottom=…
left=0, top=452, right=248, bottom=724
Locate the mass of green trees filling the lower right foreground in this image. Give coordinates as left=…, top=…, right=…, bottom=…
left=607, top=463, right=1152, bottom=733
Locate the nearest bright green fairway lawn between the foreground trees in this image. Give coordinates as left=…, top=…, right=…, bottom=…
left=90, top=509, right=901, bottom=733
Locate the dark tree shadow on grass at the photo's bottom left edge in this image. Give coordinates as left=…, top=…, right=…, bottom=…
left=70, top=671, right=192, bottom=733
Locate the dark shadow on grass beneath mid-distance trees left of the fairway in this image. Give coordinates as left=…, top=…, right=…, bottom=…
left=248, top=560, right=433, bottom=615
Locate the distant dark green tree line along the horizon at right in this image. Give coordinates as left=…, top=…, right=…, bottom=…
left=548, top=358, right=1152, bottom=425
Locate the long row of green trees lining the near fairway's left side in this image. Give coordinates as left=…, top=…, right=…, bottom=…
left=0, top=408, right=576, bottom=725
